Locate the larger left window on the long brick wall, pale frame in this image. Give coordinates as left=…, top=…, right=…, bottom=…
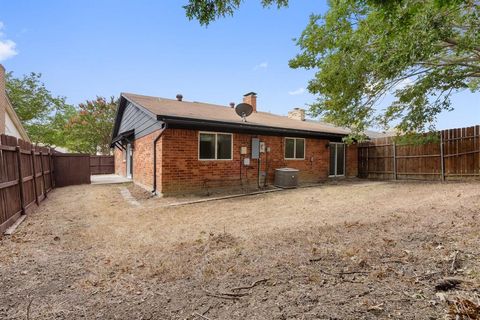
left=198, top=132, right=233, bottom=160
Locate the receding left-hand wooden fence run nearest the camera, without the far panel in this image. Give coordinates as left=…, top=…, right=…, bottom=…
left=0, top=135, right=55, bottom=233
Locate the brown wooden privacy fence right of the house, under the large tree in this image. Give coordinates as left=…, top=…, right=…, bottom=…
left=358, top=126, right=480, bottom=180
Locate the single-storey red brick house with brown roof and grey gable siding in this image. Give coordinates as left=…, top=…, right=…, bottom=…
left=112, top=92, right=357, bottom=195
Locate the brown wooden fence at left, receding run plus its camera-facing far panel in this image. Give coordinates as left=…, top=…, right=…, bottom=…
left=0, top=134, right=94, bottom=234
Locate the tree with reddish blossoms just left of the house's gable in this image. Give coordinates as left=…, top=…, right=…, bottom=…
left=66, top=97, right=117, bottom=155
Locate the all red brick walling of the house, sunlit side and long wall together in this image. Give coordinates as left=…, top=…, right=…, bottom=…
left=115, top=129, right=357, bottom=194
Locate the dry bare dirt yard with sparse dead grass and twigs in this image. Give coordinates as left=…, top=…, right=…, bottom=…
left=0, top=181, right=480, bottom=320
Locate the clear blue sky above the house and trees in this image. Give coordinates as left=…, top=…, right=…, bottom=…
left=0, top=0, right=480, bottom=129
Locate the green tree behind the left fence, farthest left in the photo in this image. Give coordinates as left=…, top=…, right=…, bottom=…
left=6, top=72, right=75, bottom=146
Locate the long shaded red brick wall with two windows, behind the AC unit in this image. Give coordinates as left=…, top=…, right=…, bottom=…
left=161, top=129, right=329, bottom=193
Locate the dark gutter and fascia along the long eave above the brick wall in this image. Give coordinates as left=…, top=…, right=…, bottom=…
left=157, top=116, right=347, bottom=141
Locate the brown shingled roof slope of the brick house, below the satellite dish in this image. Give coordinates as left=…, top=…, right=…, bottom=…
left=119, top=93, right=350, bottom=137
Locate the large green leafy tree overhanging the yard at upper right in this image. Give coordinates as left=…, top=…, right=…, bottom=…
left=185, top=0, right=480, bottom=135
